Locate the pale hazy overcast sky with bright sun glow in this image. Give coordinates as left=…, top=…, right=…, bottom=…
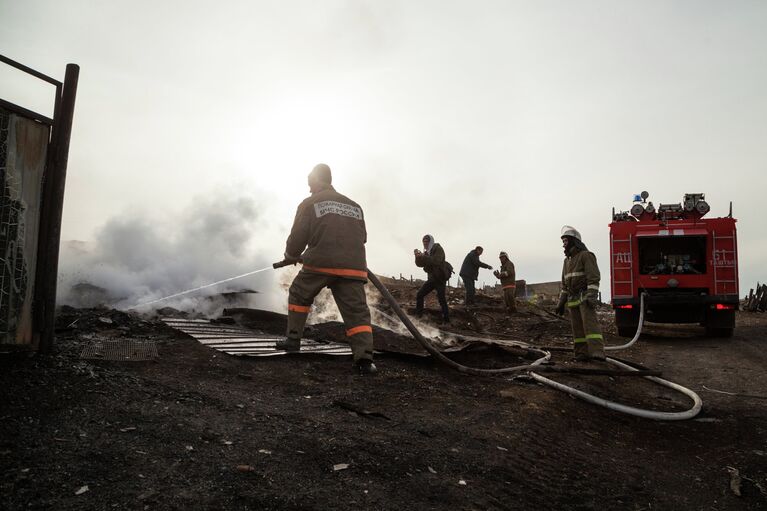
left=0, top=0, right=767, bottom=308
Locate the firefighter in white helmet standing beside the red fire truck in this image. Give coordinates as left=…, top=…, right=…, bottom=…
left=557, top=225, right=605, bottom=360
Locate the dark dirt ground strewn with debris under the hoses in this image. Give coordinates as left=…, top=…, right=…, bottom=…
left=0, top=284, right=767, bottom=510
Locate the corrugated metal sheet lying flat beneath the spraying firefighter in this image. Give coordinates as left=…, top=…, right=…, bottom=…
left=162, top=318, right=352, bottom=357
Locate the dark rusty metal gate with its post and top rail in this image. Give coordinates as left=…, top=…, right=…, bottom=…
left=0, top=55, right=79, bottom=350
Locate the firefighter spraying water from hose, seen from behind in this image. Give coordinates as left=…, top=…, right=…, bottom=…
left=277, top=163, right=376, bottom=374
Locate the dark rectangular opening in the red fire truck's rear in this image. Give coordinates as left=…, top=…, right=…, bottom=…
left=638, top=236, right=706, bottom=275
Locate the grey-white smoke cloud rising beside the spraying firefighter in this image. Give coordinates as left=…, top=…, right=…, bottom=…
left=58, top=192, right=284, bottom=314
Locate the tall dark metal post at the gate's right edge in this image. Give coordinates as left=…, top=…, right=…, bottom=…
left=35, top=64, right=80, bottom=353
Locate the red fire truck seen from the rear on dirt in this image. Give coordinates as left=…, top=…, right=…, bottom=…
left=610, top=192, right=739, bottom=337
